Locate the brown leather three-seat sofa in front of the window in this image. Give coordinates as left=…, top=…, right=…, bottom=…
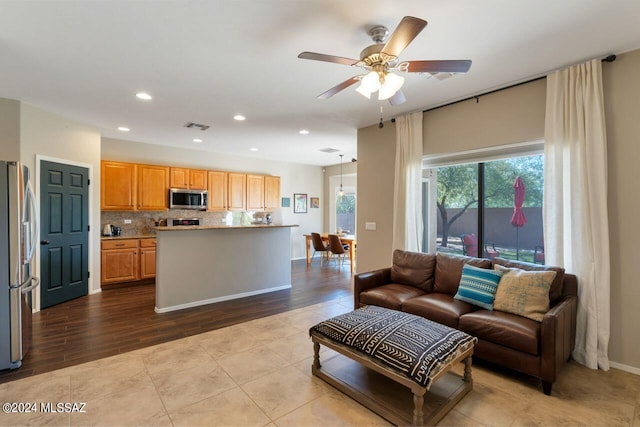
left=354, top=250, right=578, bottom=395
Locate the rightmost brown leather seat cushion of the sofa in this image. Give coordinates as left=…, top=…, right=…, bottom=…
left=458, top=310, right=540, bottom=355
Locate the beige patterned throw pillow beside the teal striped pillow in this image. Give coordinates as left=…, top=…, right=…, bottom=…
left=493, top=264, right=556, bottom=322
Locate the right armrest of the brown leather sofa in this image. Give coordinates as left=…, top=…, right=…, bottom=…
left=540, top=295, right=578, bottom=382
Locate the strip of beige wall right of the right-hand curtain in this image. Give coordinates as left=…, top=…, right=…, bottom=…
left=603, top=50, right=640, bottom=374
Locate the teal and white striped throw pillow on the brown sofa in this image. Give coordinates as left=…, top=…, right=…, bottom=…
left=454, top=264, right=502, bottom=310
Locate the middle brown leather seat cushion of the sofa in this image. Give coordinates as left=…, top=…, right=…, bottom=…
left=402, top=293, right=478, bottom=328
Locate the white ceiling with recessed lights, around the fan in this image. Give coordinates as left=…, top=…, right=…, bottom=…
left=0, top=0, right=640, bottom=165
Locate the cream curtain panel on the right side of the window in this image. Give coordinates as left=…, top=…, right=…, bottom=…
left=543, top=60, right=610, bottom=370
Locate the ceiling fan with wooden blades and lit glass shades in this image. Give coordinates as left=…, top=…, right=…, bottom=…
left=298, top=16, right=471, bottom=105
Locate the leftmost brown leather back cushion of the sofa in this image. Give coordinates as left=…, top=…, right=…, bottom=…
left=391, top=249, right=436, bottom=292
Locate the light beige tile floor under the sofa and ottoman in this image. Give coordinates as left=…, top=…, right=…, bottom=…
left=0, top=299, right=640, bottom=427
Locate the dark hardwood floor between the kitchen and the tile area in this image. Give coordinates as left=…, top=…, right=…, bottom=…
left=0, top=260, right=353, bottom=383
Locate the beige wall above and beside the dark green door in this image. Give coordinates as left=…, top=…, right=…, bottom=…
left=20, top=103, right=100, bottom=306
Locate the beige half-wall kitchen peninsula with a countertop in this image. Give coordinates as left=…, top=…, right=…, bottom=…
left=155, top=224, right=297, bottom=313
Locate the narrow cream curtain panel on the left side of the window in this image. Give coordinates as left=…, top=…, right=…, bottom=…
left=393, top=112, right=422, bottom=252
